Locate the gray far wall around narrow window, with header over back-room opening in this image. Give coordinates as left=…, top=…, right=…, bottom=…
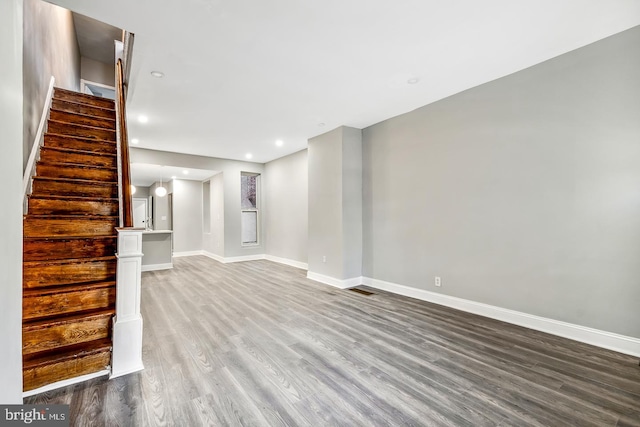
left=131, top=148, right=265, bottom=257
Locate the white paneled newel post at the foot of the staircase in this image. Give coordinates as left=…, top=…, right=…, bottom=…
left=110, top=228, right=144, bottom=378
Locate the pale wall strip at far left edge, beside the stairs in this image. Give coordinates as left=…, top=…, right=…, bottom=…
left=0, top=0, right=23, bottom=404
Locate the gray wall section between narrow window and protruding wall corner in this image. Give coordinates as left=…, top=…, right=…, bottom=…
left=263, top=150, right=308, bottom=263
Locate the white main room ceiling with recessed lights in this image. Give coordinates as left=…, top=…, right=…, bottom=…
left=47, top=0, right=640, bottom=162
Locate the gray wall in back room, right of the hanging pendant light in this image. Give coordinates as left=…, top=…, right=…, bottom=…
left=172, top=179, right=202, bottom=252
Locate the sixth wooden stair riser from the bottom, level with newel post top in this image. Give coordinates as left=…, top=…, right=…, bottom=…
left=23, top=218, right=118, bottom=237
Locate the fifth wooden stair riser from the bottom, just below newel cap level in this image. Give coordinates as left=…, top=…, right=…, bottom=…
left=22, top=238, right=117, bottom=261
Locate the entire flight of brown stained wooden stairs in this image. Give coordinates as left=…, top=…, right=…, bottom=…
left=22, top=88, right=119, bottom=391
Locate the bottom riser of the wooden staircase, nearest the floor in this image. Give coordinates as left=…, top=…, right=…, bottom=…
left=22, top=350, right=111, bottom=391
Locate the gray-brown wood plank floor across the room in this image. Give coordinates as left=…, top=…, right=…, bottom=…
left=25, top=256, right=640, bottom=427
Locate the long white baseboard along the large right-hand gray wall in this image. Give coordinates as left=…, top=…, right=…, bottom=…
left=363, top=277, right=640, bottom=357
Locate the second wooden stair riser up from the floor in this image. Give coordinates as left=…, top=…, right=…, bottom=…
left=22, top=315, right=112, bottom=355
